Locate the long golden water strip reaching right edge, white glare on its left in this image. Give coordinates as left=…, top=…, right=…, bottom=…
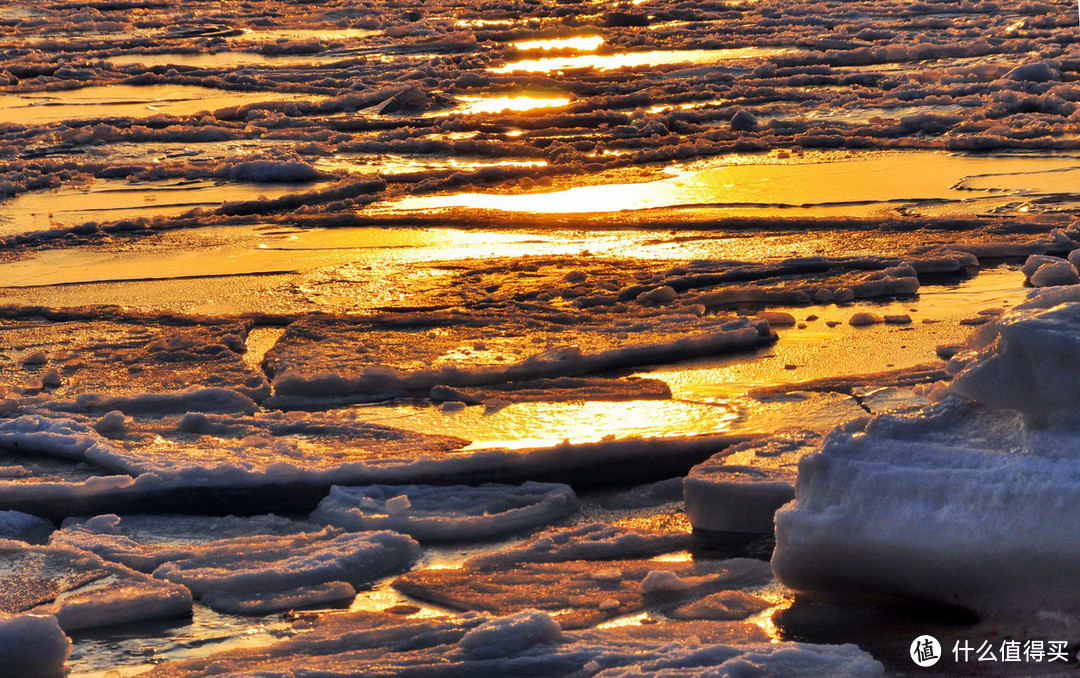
left=392, top=151, right=1080, bottom=216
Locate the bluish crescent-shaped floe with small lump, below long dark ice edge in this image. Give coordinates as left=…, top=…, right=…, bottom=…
left=311, top=483, right=578, bottom=542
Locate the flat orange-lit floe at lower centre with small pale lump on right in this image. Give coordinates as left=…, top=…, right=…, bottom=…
left=393, top=559, right=771, bottom=628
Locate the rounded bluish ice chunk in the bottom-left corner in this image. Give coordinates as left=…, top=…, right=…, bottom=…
left=0, top=612, right=71, bottom=678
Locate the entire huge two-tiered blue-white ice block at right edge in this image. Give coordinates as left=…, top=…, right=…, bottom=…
left=772, top=287, right=1080, bottom=615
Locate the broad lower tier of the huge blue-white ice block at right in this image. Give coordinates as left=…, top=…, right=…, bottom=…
left=772, top=392, right=1080, bottom=616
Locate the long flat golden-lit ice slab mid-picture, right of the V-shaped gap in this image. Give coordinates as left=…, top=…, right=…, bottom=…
left=265, top=313, right=774, bottom=407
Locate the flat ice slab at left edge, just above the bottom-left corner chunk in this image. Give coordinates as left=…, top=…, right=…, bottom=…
left=0, top=541, right=191, bottom=630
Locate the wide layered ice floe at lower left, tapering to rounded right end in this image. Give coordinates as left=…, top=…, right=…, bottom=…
left=50, top=515, right=412, bottom=614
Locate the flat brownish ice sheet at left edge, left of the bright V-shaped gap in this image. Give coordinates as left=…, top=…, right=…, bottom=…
left=0, top=310, right=269, bottom=409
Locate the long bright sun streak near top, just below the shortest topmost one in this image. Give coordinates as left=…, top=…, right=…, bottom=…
left=488, top=48, right=791, bottom=73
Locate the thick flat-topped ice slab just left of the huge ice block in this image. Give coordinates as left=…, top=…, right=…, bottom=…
left=683, top=431, right=821, bottom=534
